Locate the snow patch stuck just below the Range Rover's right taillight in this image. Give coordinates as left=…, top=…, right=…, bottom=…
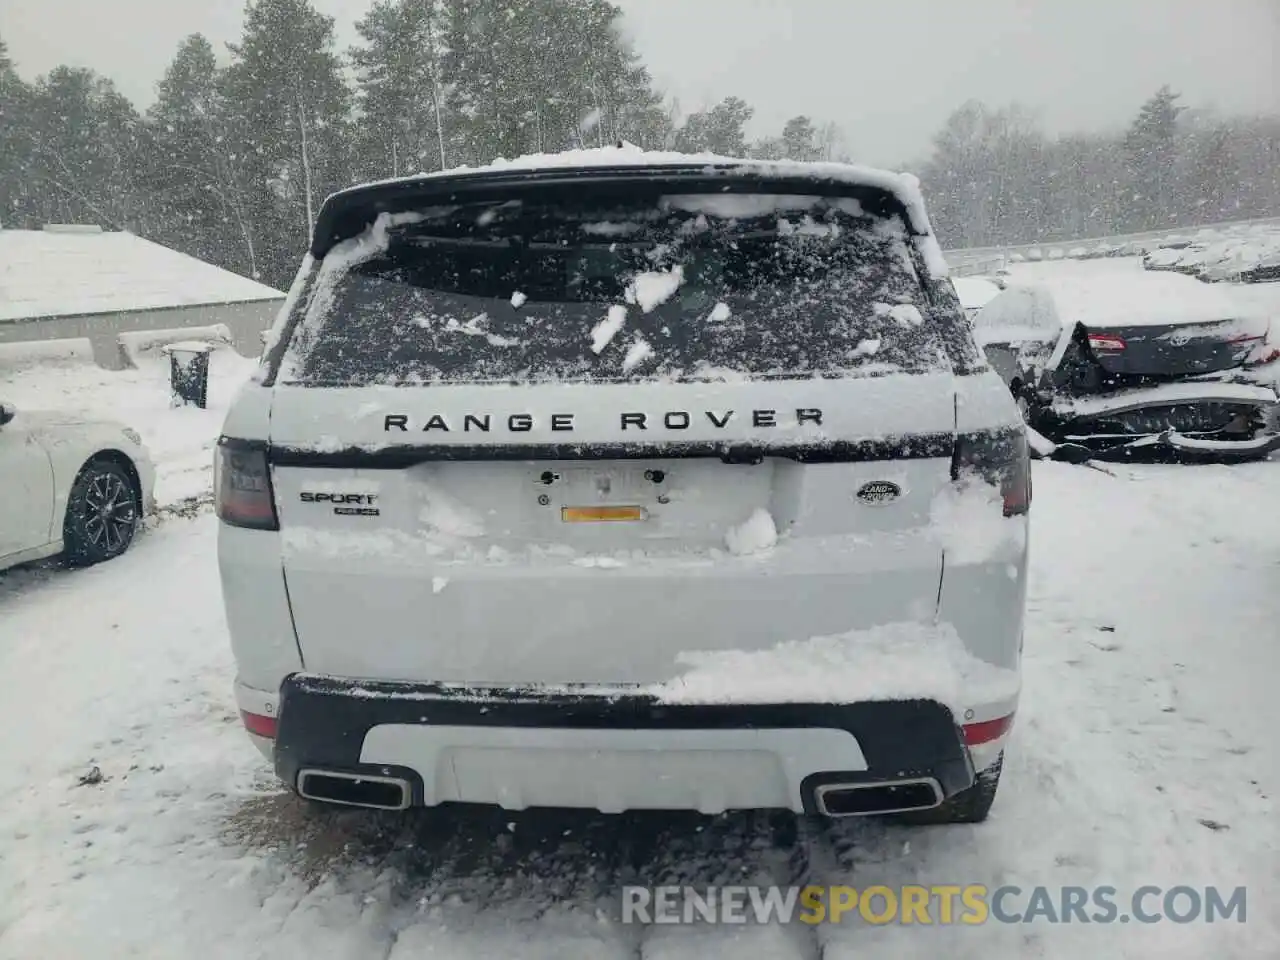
left=929, top=475, right=1027, bottom=563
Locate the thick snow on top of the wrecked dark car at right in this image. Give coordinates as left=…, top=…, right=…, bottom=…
left=998, top=260, right=1260, bottom=326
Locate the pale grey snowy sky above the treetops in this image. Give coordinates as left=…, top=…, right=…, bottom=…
left=0, top=0, right=1280, bottom=165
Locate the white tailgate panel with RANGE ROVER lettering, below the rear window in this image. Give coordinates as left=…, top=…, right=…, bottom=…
left=264, top=375, right=954, bottom=684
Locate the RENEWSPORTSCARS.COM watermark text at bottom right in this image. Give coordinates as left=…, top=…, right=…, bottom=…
left=622, top=883, right=1247, bottom=925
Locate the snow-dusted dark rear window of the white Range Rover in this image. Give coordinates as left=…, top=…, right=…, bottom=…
left=280, top=184, right=946, bottom=387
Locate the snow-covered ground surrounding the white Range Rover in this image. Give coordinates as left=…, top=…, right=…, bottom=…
left=0, top=264, right=1280, bottom=960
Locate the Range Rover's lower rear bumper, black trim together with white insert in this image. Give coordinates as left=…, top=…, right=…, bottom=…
left=264, top=675, right=1012, bottom=814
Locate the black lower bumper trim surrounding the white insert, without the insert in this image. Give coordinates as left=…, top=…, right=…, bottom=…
left=275, top=673, right=974, bottom=813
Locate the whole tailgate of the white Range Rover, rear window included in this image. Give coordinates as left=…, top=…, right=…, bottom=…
left=257, top=180, right=964, bottom=685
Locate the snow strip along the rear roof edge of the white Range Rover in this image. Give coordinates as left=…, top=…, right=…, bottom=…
left=325, top=143, right=947, bottom=278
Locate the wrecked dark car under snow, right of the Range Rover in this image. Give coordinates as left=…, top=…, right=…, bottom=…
left=973, top=268, right=1280, bottom=462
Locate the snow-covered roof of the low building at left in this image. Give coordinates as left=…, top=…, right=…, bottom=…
left=0, top=230, right=284, bottom=323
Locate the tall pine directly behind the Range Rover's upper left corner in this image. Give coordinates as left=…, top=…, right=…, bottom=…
left=223, top=0, right=351, bottom=287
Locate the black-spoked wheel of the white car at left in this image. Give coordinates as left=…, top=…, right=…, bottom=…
left=63, top=460, right=142, bottom=567
